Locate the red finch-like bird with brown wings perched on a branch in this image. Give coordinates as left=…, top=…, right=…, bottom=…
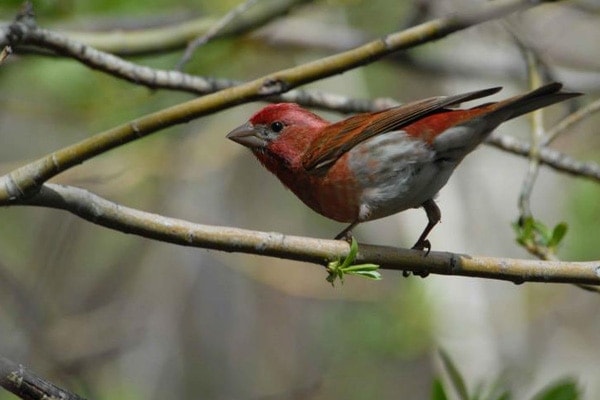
left=227, top=82, right=581, bottom=253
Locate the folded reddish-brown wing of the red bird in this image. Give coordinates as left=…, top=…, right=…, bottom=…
left=302, top=87, right=501, bottom=172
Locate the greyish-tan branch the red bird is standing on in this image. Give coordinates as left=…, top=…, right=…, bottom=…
left=15, top=184, right=600, bottom=285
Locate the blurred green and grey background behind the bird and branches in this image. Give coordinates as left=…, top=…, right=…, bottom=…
left=0, top=0, right=600, bottom=399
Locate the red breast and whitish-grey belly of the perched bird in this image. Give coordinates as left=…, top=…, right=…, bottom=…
left=260, top=131, right=452, bottom=222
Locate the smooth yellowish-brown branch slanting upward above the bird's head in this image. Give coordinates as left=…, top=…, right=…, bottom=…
left=0, top=0, right=556, bottom=204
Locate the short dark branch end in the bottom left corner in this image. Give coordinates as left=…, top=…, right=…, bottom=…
left=0, top=356, right=84, bottom=400
